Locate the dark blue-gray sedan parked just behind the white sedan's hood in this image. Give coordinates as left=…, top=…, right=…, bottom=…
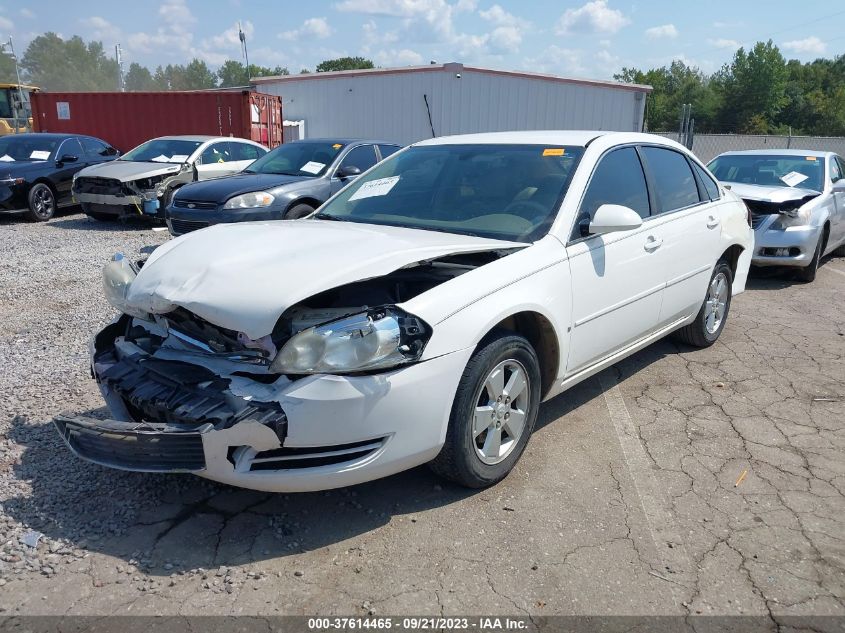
left=165, top=139, right=401, bottom=235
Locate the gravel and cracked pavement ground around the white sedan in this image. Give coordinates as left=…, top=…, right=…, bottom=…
left=0, top=209, right=845, bottom=620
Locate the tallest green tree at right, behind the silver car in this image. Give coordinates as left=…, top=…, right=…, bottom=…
left=716, top=40, right=788, bottom=134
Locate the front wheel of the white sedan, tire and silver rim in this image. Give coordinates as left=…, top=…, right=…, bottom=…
left=431, top=332, right=540, bottom=488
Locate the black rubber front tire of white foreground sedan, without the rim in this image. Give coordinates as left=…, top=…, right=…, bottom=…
left=429, top=332, right=540, bottom=488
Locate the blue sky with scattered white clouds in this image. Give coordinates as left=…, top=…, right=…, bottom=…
left=0, top=0, right=845, bottom=79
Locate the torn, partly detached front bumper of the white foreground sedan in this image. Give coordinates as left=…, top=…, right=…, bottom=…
left=54, top=318, right=472, bottom=492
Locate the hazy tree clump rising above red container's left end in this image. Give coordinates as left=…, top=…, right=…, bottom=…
left=21, top=32, right=117, bottom=92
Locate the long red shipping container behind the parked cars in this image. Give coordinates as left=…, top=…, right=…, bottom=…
left=31, top=90, right=283, bottom=153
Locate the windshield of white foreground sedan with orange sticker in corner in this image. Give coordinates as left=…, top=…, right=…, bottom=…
left=317, top=145, right=584, bottom=242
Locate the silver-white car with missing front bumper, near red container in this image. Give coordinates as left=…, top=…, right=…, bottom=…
left=73, top=136, right=268, bottom=221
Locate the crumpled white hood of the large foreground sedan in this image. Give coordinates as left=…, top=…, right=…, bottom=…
left=127, top=220, right=527, bottom=339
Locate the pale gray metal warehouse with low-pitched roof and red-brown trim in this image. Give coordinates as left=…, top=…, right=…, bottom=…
left=252, top=63, right=651, bottom=144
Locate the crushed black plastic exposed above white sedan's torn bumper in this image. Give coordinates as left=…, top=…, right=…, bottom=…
left=96, top=354, right=287, bottom=432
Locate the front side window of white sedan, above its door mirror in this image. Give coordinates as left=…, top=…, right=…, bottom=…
left=572, top=147, right=651, bottom=239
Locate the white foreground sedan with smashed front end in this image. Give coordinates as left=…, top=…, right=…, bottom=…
left=55, top=131, right=753, bottom=491
